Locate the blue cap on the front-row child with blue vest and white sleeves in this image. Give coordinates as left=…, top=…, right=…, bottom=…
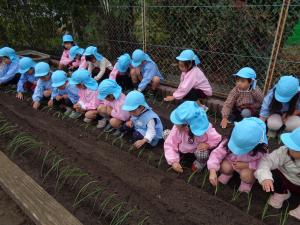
left=122, top=91, right=150, bottom=111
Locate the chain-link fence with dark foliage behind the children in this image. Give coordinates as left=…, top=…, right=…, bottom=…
left=0, top=0, right=300, bottom=95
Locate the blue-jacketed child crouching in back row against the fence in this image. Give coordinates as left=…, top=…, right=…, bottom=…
left=130, top=49, right=163, bottom=93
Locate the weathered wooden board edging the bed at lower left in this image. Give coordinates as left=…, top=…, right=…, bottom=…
left=0, top=151, right=82, bottom=225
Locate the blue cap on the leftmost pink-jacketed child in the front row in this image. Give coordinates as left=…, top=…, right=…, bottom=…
left=70, top=69, right=98, bottom=91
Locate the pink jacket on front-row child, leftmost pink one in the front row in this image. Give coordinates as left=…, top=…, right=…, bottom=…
left=78, top=88, right=104, bottom=111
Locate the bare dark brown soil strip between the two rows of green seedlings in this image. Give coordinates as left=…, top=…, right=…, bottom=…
left=0, top=93, right=297, bottom=225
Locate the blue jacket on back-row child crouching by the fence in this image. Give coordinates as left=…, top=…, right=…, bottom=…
left=138, top=61, right=164, bottom=91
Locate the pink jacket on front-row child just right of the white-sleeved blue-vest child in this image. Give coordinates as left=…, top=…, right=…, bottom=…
left=164, top=124, right=222, bottom=165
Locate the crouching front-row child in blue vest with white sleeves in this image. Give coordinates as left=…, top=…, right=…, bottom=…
left=122, top=91, right=163, bottom=149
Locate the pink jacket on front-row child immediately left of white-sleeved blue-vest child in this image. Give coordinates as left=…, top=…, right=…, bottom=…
left=104, top=93, right=130, bottom=121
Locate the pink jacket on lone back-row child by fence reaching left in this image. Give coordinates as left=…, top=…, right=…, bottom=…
left=173, top=66, right=212, bottom=99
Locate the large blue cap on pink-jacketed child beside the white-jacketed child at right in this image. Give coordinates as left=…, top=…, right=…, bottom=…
left=228, top=117, right=268, bottom=155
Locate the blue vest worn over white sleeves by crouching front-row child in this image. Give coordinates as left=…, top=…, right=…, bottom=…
left=131, top=109, right=163, bottom=146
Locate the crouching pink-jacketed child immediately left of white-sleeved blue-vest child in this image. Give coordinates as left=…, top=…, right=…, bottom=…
left=97, top=79, right=130, bottom=132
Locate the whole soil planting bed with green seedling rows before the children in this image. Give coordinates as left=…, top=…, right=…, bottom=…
left=0, top=93, right=299, bottom=225
